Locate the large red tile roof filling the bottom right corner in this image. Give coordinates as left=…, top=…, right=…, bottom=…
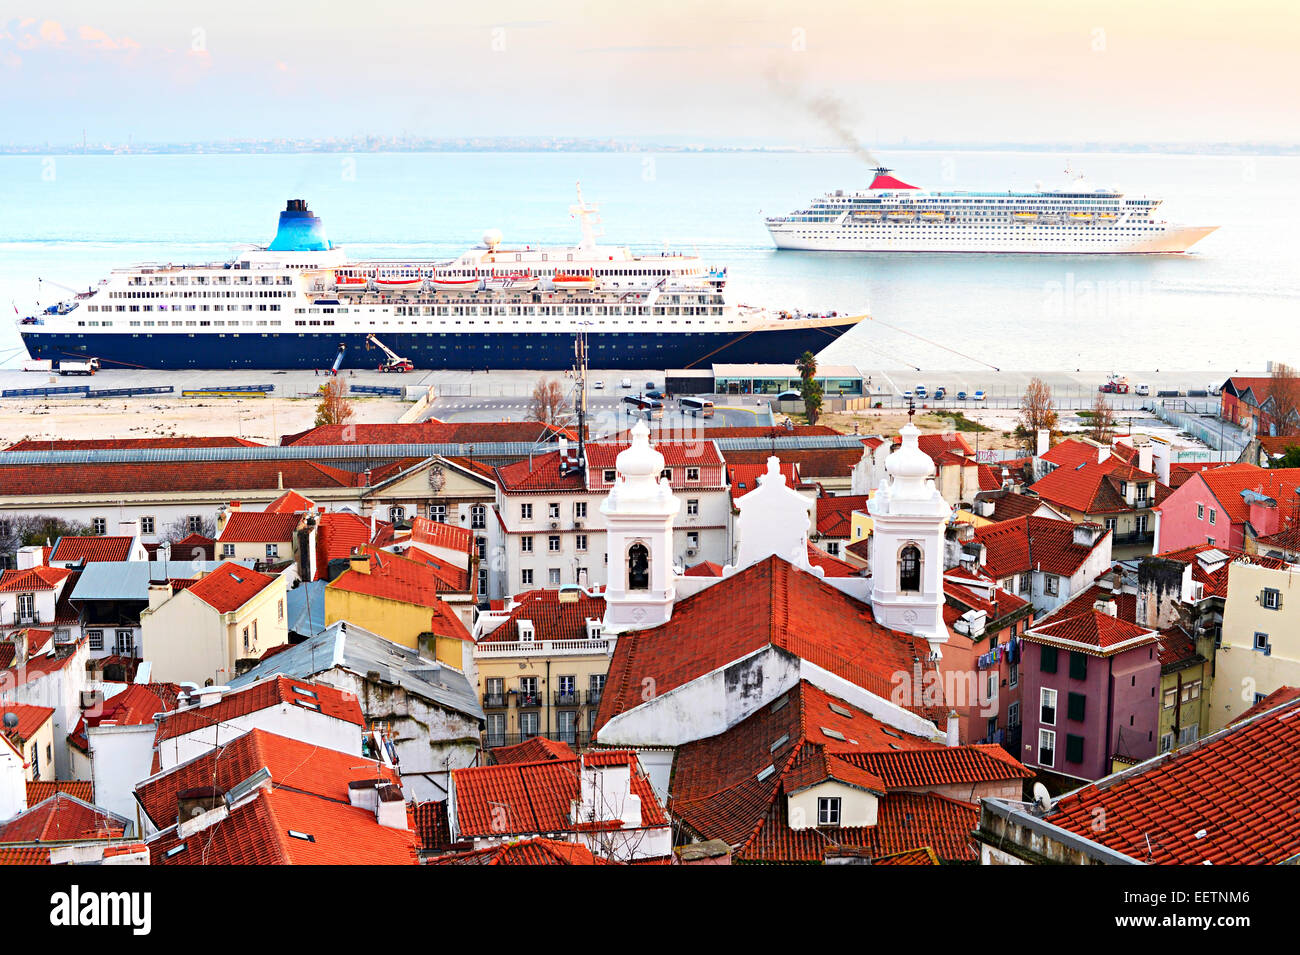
left=1043, top=699, right=1300, bottom=865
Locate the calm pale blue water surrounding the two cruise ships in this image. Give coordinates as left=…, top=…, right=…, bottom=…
left=0, top=152, right=1300, bottom=381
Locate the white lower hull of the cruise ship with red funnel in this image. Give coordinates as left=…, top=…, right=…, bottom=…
left=767, top=222, right=1218, bottom=255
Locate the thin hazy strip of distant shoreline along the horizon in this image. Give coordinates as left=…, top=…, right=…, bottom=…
left=0, top=138, right=1300, bottom=156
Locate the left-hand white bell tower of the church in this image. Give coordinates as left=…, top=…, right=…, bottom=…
left=601, top=421, right=681, bottom=633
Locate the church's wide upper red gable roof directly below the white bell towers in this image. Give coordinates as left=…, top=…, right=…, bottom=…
left=595, top=556, right=944, bottom=728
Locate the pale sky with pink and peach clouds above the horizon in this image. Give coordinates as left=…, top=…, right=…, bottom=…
left=0, top=0, right=1300, bottom=147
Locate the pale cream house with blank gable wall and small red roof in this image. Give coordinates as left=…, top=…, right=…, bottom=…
left=140, top=561, right=289, bottom=686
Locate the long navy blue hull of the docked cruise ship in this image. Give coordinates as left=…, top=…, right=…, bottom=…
left=21, top=327, right=855, bottom=370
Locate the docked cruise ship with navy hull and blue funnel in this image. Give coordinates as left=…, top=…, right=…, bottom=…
left=20, top=187, right=866, bottom=370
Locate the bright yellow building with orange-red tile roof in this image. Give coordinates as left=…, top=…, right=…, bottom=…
left=325, top=547, right=472, bottom=670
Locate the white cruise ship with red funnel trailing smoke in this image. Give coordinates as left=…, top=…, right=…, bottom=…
left=767, top=166, right=1218, bottom=255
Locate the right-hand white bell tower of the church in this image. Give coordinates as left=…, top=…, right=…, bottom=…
left=867, top=422, right=952, bottom=660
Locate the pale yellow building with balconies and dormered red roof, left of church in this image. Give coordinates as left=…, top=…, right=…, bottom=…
left=475, top=587, right=614, bottom=748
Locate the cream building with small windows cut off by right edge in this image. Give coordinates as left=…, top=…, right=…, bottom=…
left=1209, top=559, right=1300, bottom=732
